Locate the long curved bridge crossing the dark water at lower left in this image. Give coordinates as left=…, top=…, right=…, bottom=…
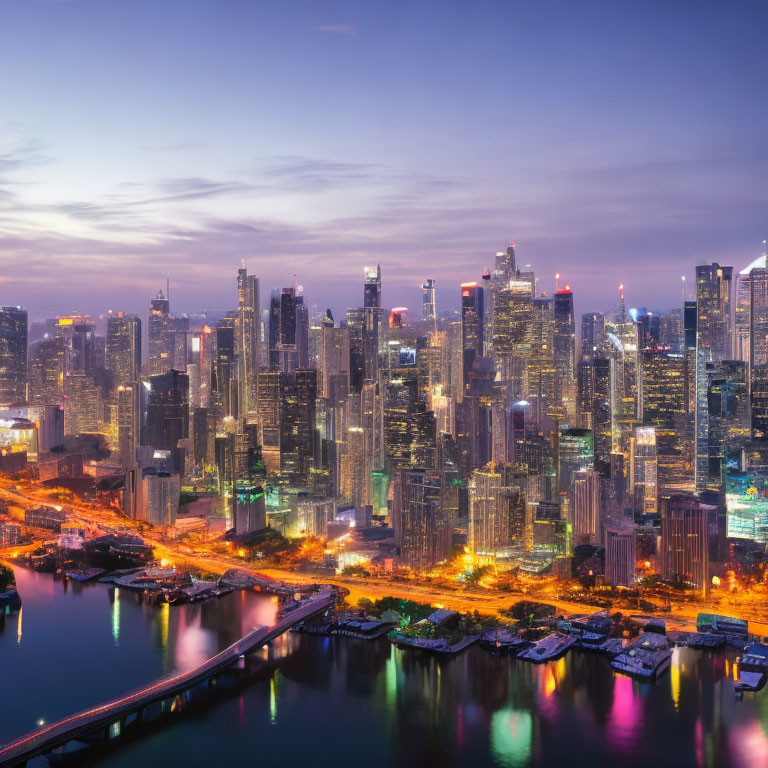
left=0, top=587, right=336, bottom=768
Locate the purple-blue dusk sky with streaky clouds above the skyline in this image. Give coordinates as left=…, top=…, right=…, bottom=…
left=0, top=0, right=768, bottom=318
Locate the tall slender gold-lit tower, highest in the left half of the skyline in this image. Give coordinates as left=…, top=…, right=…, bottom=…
left=235, top=266, right=261, bottom=413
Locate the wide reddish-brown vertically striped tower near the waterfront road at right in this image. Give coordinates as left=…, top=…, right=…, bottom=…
left=661, top=494, right=717, bottom=595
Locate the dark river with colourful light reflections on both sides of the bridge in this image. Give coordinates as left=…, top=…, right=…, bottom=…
left=0, top=569, right=768, bottom=768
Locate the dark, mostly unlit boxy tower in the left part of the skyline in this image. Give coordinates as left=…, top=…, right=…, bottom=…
left=141, top=369, right=189, bottom=475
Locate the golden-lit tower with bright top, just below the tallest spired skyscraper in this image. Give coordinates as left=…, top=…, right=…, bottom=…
left=493, top=280, right=533, bottom=399
